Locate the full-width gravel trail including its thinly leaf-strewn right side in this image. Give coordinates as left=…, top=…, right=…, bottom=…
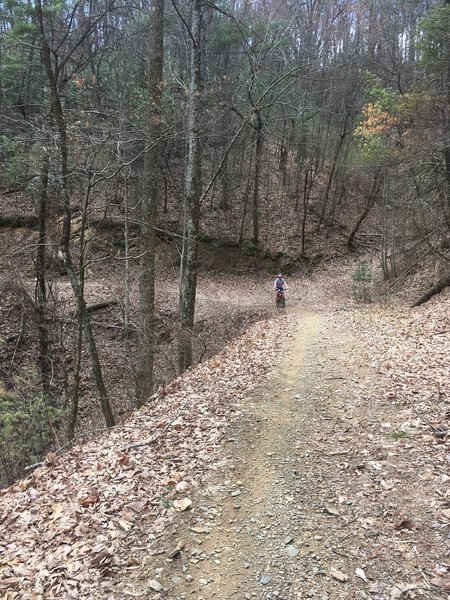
left=134, top=308, right=447, bottom=600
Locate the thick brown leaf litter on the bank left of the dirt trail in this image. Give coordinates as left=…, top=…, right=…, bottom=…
left=0, top=322, right=286, bottom=600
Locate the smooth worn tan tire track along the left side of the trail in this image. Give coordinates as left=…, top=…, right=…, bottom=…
left=147, top=308, right=334, bottom=600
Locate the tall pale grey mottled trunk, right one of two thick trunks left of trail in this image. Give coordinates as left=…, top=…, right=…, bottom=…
left=178, top=0, right=202, bottom=372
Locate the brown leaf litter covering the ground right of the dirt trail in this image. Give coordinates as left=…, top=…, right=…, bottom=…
left=338, top=291, right=450, bottom=598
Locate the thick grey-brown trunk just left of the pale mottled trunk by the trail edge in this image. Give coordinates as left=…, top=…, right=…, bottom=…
left=137, top=0, right=164, bottom=404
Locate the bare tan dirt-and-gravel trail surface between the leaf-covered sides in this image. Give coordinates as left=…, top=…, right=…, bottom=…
left=141, top=308, right=354, bottom=600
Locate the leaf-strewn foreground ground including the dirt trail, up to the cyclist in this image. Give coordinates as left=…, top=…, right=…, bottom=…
left=0, top=271, right=450, bottom=600
